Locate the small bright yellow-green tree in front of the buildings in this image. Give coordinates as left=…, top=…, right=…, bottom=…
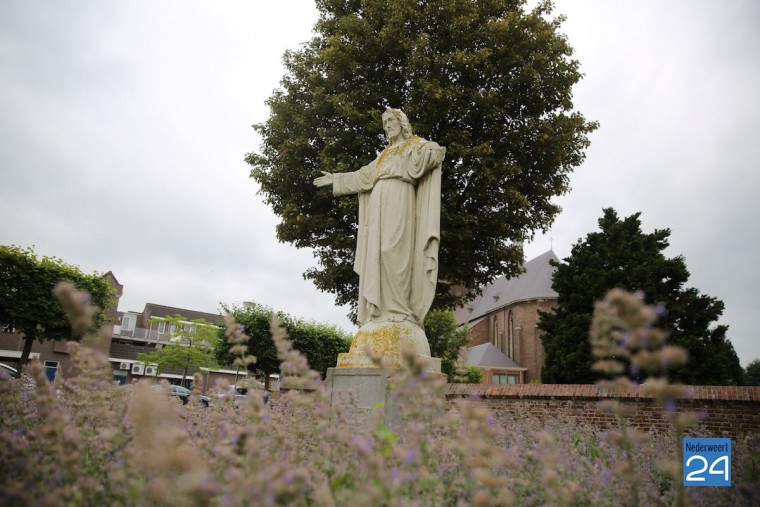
left=138, top=315, right=219, bottom=383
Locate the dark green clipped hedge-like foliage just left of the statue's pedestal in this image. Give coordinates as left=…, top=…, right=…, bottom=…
left=216, top=303, right=351, bottom=378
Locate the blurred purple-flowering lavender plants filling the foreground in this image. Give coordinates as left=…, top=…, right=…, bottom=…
left=0, top=286, right=760, bottom=506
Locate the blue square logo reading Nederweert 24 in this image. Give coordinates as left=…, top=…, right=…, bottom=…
left=683, top=438, right=731, bottom=486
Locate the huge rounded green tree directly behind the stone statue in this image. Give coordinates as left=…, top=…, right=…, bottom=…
left=246, top=0, right=596, bottom=320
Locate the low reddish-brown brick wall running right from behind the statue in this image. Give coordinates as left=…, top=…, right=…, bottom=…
left=446, top=384, right=760, bottom=437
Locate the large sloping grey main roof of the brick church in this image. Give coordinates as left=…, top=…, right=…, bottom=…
left=454, top=250, right=559, bottom=325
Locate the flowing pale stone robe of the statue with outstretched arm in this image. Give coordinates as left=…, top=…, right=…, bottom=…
left=333, top=136, right=445, bottom=326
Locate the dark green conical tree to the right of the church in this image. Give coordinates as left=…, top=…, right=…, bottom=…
left=539, top=208, right=743, bottom=385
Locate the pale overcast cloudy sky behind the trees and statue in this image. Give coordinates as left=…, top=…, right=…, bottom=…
left=0, top=0, right=760, bottom=366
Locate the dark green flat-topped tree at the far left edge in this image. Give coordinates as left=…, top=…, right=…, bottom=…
left=0, top=245, right=116, bottom=378
